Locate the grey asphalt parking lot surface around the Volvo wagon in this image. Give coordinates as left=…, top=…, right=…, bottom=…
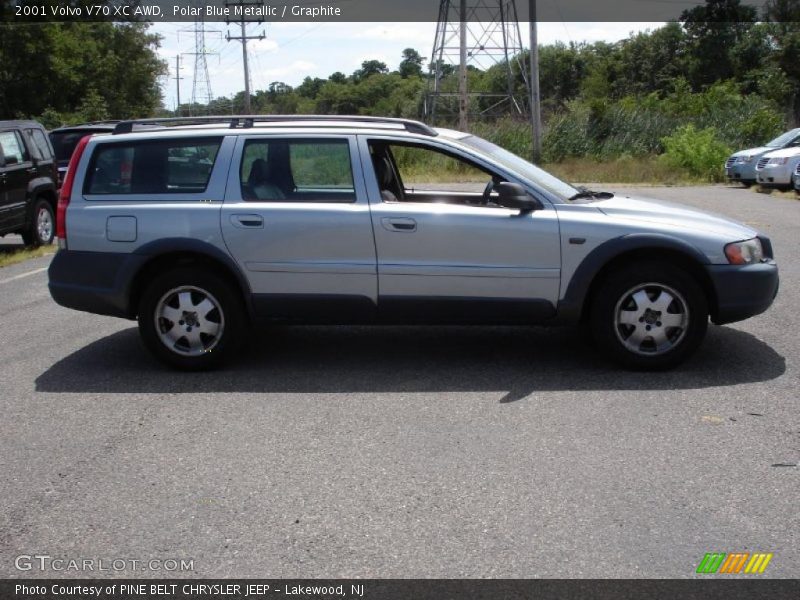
left=0, top=186, right=800, bottom=578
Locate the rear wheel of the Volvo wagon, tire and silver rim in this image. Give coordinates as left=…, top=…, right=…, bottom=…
left=137, top=267, right=246, bottom=371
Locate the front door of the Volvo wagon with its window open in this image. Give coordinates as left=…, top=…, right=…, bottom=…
left=359, top=136, right=561, bottom=322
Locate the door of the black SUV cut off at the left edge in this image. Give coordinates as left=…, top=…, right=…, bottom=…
left=0, top=129, right=35, bottom=230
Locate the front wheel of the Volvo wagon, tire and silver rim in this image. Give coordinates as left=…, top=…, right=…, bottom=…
left=590, top=261, right=708, bottom=370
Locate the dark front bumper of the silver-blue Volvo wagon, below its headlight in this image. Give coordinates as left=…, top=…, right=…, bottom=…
left=706, top=261, right=779, bottom=325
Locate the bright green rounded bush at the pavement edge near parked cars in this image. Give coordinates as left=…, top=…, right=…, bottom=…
left=661, top=124, right=731, bottom=181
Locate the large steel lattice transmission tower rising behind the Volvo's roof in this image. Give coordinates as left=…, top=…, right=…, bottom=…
left=424, top=0, right=530, bottom=131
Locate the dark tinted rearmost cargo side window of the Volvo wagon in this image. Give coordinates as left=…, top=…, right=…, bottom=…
left=84, top=138, right=222, bottom=195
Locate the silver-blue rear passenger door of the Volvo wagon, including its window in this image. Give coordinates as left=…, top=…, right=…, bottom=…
left=222, top=134, right=377, bottom=322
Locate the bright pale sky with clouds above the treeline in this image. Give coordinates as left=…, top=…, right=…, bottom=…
left=152, top=22, right=662, bottom=108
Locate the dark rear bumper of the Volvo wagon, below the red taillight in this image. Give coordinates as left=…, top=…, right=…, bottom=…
left=47, top=250, right=148, bottom=319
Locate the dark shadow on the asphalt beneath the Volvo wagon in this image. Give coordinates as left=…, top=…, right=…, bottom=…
left=36, top=326, right=786, bottom=402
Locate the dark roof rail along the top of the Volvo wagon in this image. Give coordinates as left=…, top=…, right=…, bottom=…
left=114, top=115, right=439, bottom=136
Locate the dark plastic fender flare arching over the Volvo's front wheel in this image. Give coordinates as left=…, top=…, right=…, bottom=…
left=558, top=233, right=710, bottom=320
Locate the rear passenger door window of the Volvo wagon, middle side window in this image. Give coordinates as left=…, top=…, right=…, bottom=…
left=240, top=139, right=356, bottom=202
